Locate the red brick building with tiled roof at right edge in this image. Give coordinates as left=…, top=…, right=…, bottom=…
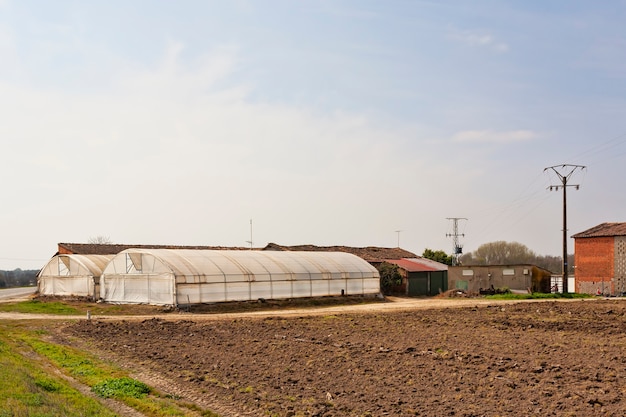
left=572, top=223, right=626, bottom=295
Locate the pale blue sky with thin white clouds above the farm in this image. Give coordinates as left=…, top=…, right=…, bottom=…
left=0, top=0, right=626, bottom=270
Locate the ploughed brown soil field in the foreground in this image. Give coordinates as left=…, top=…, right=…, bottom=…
left=64, top=300, right=626, bottom=416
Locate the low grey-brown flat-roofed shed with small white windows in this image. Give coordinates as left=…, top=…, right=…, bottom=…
left=448, top=264, right=552, bottom=293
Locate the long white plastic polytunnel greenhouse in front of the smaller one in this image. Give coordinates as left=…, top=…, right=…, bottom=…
left=100, top=249, right=380, bottom=306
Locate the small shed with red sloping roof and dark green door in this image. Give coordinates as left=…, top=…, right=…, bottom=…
left=385, top=257, right=448, bottom=296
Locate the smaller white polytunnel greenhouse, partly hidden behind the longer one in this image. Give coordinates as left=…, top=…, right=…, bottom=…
left=37, top=255, right=113, bottom=299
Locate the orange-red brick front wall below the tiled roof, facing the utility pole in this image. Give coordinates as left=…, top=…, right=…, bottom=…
left=574, top=237, right=615, bottom=294
